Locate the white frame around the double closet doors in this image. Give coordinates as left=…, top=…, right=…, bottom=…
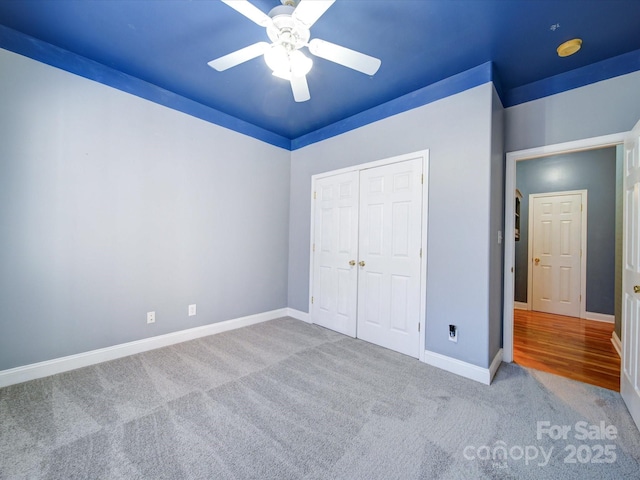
left=308, top=149, right=429, bottom=362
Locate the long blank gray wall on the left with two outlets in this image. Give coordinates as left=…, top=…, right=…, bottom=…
left=0, top=50, right=290, bottom=370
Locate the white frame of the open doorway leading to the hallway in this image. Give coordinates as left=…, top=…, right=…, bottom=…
left=502, top=132, right=628, bottom=363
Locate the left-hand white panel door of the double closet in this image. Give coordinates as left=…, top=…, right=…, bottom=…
left=311, top=172, right=359, bottom=337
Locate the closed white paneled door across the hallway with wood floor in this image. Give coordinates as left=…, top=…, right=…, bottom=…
left=529, top=193, right=582, bottom=317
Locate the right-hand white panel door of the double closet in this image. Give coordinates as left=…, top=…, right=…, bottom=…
left=358, top=158, right=422, bottom=358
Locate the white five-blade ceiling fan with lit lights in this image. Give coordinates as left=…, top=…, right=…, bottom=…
left=209, top=0, right=381, bottom=102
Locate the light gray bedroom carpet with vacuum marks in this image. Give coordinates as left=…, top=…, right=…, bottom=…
left=0, top=318, right=640, bottom=480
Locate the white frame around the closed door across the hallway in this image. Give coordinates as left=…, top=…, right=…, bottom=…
left=528, top=190, right=588, bottom=318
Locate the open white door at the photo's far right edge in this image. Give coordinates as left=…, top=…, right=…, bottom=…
left=620, top=118, right=640, bottom=428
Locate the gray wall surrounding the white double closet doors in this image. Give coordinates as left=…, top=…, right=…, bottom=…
left=289, top=83, right=502, bottom=367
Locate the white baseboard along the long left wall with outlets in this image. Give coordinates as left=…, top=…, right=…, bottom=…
left=0, top=308, right=292, bottom=388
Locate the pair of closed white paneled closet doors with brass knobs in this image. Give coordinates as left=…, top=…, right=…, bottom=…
left=311, top=158, right=423, bottom=358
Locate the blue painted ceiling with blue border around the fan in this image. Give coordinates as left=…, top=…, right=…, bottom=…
left=0, top=0, right=640, bottom=139
